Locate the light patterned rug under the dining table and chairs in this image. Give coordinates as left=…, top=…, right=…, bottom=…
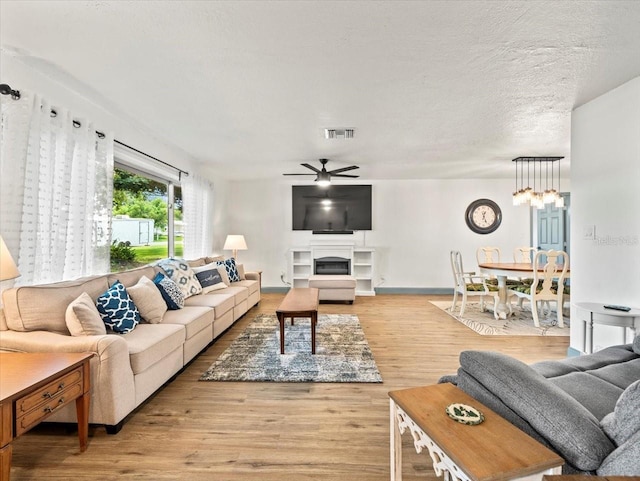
left=431, top=301, right=570, bottom=336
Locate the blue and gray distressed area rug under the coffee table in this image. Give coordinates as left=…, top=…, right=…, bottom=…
left=200, top=314, right=382, bottom=383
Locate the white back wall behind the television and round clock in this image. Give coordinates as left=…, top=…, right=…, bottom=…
left=229, top=179, right=529, bottom=288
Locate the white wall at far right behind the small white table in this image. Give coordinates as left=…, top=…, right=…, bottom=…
left=571, top=77, right=640, bottom=350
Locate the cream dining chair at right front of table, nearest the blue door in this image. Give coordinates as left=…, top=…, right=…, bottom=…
left=509, top=249, right=569, bottom=327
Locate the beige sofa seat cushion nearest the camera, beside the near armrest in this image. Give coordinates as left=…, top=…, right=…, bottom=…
left=122, top=323, right=185, bottom=375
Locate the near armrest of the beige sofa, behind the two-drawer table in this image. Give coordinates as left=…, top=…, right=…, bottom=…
left=0, top=331, right=136, bottom=425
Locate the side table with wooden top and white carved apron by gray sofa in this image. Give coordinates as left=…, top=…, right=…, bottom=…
left=389, top=384, right=564, bottom=481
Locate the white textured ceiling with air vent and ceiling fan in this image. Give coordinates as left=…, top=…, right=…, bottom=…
left=0, top=0, right=640, bottom=179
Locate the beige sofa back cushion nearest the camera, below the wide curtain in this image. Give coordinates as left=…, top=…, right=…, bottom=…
left=2, top=276, right=109, bottom=335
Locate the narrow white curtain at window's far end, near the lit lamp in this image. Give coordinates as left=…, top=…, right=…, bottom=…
left=181, top=174, right=214, bottom=259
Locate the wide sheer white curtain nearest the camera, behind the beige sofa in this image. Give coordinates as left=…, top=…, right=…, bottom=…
left=0, top=92, right=113, bottom=285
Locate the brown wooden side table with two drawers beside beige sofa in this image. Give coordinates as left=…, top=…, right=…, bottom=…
left=0, top=352, right=93, bottom=481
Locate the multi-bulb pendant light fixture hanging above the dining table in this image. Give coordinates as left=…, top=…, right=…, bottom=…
left=513, top=157, right=564, bottom=209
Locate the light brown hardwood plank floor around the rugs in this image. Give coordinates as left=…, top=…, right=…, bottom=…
left=11, top=294, right=569, bottom=481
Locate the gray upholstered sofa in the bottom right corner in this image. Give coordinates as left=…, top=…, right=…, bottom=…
left=439, top=344, right=640, bottom=476
